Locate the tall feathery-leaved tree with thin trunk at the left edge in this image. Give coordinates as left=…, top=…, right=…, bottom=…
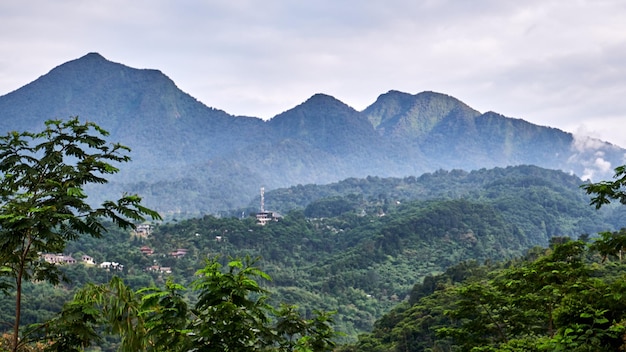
left=0, top=117, right=160, bottom=351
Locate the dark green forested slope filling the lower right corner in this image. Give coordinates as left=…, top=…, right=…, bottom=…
left=340, top=234, right=626, bottom=352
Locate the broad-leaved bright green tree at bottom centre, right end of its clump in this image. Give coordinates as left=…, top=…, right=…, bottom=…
left=190, top=257, right=335, bottom=352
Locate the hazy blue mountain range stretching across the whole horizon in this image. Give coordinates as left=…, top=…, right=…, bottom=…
left=0, top=53, right=626, bottom=213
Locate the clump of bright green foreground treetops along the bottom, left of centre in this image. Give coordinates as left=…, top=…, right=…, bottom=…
left=37, top=257, right=336, bottom=352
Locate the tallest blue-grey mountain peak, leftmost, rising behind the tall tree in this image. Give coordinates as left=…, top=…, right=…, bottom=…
left=0, top=53, right=264, bottom=180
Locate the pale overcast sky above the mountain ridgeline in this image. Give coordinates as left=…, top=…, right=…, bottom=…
left=0, top=0, right=626, bottom=147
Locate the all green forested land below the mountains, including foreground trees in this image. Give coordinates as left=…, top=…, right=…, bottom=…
left=0, top=118, right=626, bottom=352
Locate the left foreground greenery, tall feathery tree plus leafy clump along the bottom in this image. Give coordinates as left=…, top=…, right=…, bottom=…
left=0, top=118, right=335, bottom=352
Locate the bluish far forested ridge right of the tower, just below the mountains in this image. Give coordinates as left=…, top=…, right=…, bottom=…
left=251, top=165, right=626, bottom=245
